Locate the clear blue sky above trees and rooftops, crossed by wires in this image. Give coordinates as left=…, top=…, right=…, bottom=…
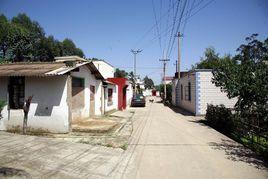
left=0, top=0, right=268, bottom=83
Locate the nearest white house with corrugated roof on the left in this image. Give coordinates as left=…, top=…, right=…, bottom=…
left=0, top=56, right=109, bottom=133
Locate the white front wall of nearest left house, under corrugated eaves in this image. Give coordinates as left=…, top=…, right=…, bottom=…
left=0, top=76, right=69, bottom=133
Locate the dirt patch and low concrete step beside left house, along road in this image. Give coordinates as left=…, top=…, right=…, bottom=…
left=53, top=110, right=134, bottom=150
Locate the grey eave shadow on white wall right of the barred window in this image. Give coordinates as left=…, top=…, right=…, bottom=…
left=28, top=77, right=66, bottom=116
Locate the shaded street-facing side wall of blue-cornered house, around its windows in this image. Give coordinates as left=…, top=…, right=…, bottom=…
left=178, top=73, right=196, bottom=113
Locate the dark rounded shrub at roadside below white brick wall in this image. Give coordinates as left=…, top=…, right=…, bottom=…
left=206, top=104, right=234, bottom=133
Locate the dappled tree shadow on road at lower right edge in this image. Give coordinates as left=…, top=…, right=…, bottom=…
left=209, top=139, right=268, bottom=170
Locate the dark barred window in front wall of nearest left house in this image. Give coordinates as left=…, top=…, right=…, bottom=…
left=8, top=77, right=25, bottom=109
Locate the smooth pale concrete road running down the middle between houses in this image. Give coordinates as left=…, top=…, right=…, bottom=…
left=113, top=99, right=268, bottom=179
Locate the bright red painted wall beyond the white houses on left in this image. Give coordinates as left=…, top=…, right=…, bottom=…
left=107, top=78, right=128, bottom=110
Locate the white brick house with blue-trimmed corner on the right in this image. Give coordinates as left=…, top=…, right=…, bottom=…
left=172, top=69, right=237, bottom=115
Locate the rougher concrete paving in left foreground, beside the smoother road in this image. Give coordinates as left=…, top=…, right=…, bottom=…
left=0, top=132, right=123, bottom=178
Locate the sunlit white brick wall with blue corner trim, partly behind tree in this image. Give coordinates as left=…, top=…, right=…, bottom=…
left=196, top=71, right=237, bottom=115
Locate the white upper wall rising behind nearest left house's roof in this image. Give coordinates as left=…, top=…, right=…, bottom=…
left=93, top=60, right=115, bottom=79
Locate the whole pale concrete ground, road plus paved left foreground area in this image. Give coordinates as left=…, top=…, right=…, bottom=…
left=0, top=98, right=268, bottom=179
